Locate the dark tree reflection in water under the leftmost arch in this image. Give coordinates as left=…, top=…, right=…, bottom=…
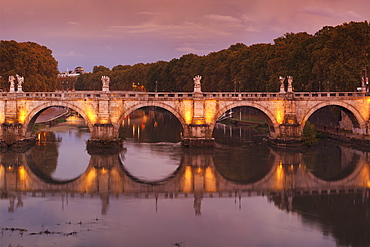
left=31, top=131, right=61, bottom=176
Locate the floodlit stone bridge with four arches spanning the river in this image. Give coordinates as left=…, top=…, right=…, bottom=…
left=0, top=88, right=370, bottom=146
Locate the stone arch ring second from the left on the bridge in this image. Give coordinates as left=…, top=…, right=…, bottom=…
left=116, top=101, right=186, bottom=131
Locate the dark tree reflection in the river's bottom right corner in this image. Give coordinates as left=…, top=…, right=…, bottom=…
left=272, top=193, right=370, bottom=246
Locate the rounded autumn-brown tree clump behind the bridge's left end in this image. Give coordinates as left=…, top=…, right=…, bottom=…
left=0, top=40, right=58, bottom=92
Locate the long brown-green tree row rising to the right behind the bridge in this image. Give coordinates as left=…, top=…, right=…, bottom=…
left=76, top=21, right=370, bottom=91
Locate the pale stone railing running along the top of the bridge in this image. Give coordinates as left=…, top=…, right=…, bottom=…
left=0, top=91, right=365, bottom=100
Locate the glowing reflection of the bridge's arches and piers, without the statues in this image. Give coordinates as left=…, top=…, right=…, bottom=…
left=0, top=148, right=370, bottom=196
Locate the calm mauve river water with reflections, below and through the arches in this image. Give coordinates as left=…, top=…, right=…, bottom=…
left=0, top=109, right=370, bottom=247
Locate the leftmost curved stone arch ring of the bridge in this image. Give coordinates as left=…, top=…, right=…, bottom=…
left=24, top=101, right=93, bottom=137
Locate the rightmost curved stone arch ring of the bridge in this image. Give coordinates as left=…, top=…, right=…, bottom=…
left=300, top=101, right=366, bottom=131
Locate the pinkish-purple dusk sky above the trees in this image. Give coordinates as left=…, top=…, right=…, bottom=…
left=0, top=0, right=370, bottom=72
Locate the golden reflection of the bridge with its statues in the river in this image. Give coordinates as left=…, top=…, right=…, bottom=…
left=0, top=147, right=370, bottom=212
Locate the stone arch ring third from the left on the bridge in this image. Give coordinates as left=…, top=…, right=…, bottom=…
left=212, top=101, right=280, bottom=137
